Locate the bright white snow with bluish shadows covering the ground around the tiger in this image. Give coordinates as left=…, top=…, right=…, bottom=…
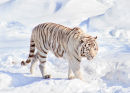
left=0, top=0, right=130, bottom=93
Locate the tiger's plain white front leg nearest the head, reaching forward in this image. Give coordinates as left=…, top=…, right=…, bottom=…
left=70, top=61, right=84, bottom=81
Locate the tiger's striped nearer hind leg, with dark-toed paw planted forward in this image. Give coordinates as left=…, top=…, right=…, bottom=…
left=38, top=54, right=51, bottom=79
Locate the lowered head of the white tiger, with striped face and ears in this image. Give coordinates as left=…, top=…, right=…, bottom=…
left=80, top=36, right=98, bottom=60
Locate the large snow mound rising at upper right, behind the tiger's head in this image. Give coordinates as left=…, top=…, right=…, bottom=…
left=83, top=0, right=130, bottom=45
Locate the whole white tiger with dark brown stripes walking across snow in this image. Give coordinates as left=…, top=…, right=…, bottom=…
left=21, top=23, right=98, bottom=80
